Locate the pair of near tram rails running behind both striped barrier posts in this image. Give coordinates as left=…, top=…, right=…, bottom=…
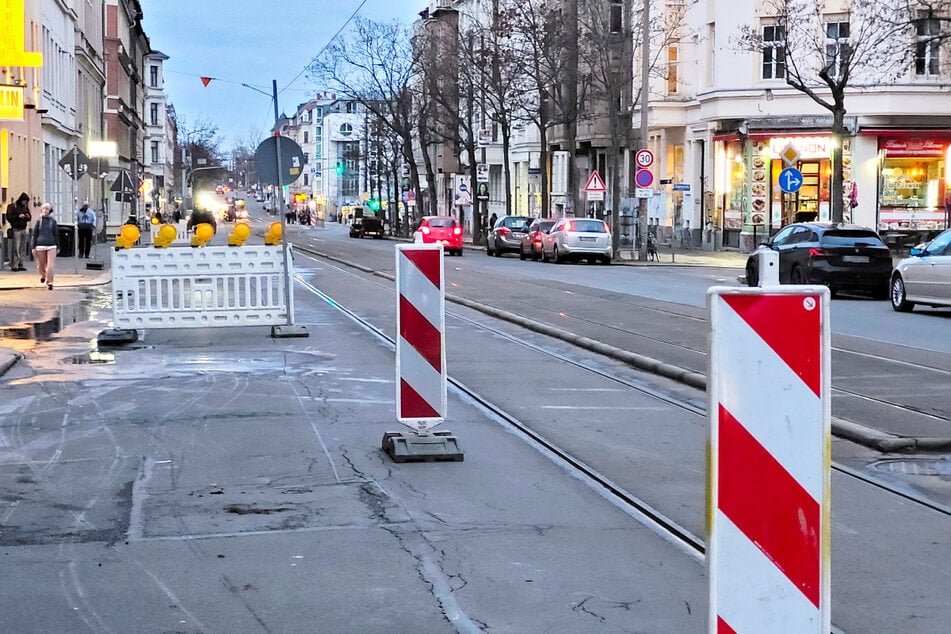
left=297, top=252, right=951, bottom=532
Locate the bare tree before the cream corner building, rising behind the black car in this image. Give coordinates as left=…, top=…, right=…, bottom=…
left=739, top=0, right=909, bottom=222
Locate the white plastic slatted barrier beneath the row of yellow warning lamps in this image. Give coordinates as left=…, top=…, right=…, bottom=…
left=112, top=246, right=294, bottom=329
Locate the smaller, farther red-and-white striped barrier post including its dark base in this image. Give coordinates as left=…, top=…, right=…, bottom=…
left=383, top=244, right=462, bottom=462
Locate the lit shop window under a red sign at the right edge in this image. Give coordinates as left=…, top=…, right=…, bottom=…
left=878, top=136, right=951, bottom=231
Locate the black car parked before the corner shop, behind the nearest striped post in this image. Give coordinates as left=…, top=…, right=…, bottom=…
left=746, top=222, right=892, bottom=299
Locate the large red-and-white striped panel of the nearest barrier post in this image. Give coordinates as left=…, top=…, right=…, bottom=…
left=707, top=286, right=831, bottom=634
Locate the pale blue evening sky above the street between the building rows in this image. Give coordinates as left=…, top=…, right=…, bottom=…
left=140, top=0, right=428, bottom=151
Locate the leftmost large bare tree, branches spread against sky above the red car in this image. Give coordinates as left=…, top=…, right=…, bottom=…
left=308, top=18, right=425, bottom=230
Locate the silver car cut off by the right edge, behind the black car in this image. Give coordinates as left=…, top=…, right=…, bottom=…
left=889, top=229, right=951, bottom=312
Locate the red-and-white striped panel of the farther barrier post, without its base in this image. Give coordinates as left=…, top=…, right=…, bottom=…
left=396, top=244, right=446, bottom=430
